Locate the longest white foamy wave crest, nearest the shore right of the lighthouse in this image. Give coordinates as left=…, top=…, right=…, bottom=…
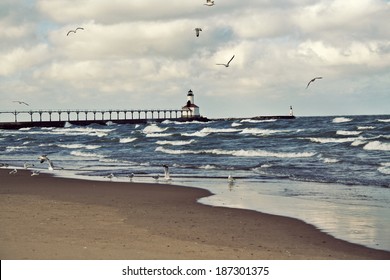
left=155, top=147, right=315, bottom=158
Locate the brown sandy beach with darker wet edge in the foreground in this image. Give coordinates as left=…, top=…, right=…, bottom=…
left=0, top=169, right=390, bottom=260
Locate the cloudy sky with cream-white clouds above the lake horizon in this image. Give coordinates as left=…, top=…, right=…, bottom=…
left=0, top=0, right=390, bottom=117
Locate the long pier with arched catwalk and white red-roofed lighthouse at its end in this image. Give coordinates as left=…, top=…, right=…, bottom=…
left=0, top=90, right=208, bottom=129
